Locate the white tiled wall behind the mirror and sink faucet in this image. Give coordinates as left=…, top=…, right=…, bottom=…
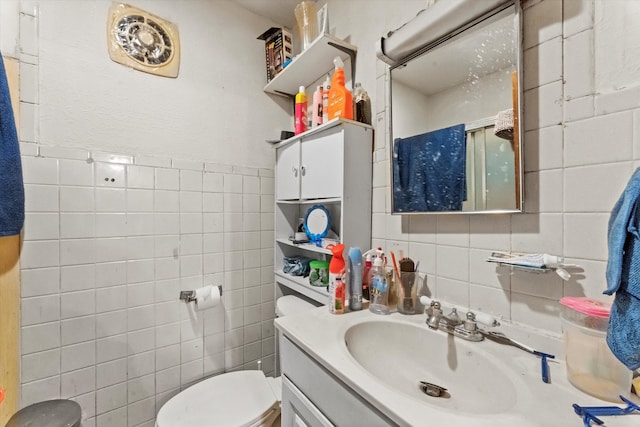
left=329, top=0, right=640, bottom=333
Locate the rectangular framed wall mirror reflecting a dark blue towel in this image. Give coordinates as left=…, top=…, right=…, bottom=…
left=390, top=2, right=523, bottom=214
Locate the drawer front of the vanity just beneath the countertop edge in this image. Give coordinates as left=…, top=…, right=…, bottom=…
left=279, top=334, right=397, bottom=427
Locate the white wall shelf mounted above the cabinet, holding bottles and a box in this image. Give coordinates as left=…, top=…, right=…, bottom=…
left=264, top=34, right=358, bottom=96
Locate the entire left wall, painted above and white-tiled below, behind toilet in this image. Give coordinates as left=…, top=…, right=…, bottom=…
left=10, top=0, right=282, bottom=427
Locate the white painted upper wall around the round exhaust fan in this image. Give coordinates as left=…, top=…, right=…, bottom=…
left=35, top=0, right=291, bottom=167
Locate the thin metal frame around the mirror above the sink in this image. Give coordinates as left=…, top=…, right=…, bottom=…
left=387, top=0, right=524, bottom=215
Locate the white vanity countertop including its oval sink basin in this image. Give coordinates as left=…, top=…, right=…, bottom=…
left=275, top=307, right=640, bottom=427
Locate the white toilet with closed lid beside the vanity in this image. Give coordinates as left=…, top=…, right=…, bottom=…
left=156, top=295, right=315, bottom=427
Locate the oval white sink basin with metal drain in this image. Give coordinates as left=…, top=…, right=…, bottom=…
left=345, top=319, right=517, bottom=414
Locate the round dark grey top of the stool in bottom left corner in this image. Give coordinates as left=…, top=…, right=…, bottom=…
left=5, top=399, right=82, bottom=427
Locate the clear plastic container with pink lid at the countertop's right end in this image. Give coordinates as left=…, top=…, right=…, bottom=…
left=560, top=297, right=633, bottom=402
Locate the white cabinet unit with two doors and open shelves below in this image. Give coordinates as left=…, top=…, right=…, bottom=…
left=274, top=119, right=373, bottom=304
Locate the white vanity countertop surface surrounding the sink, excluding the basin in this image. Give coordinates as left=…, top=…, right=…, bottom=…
left=275, top=306, right=640, bottom=427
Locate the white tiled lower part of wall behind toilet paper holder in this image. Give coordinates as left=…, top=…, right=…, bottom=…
left=21, top=144, right=274, bottom=427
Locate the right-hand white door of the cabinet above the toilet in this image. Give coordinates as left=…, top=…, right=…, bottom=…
left=300, top=127, right=344, bottom=199
